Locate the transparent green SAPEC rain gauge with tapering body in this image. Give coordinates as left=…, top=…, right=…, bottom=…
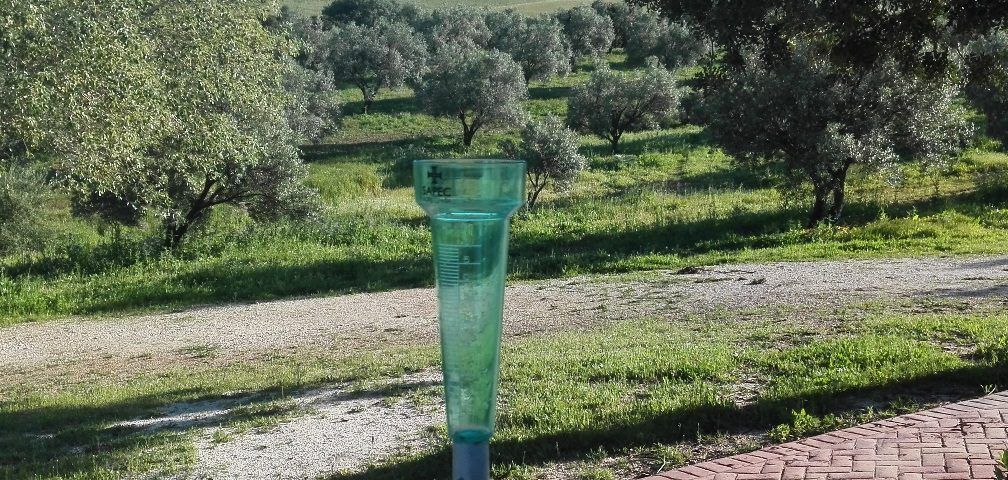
left=413, top=159, right=525, bottom=480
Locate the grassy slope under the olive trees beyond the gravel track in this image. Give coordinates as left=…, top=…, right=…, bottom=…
left=0, top=56, right=1008, bottom=325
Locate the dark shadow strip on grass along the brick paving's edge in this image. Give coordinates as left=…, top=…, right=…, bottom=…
left=330, top=365, right=1008, bottom=480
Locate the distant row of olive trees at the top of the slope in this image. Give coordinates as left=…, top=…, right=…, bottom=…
left=288, top=0, right=705, bottom=112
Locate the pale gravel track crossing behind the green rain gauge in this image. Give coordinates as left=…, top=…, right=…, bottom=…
left=0, top=256, right=1008, bottom=374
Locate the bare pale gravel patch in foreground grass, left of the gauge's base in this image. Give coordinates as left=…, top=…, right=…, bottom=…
left=189, top=372, right=445, bottom=480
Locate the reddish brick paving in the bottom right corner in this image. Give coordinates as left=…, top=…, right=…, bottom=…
left=645, top=391, right=1008, bottom=480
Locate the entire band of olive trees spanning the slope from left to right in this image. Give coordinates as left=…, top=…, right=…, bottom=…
left=7, top=0, right=1008, bottom=255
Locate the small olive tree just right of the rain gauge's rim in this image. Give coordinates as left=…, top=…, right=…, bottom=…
left=501, top=116, right=588, bottom=210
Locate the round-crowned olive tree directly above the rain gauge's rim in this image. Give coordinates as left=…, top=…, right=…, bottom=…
left=416, top=46, right=528, bottom=147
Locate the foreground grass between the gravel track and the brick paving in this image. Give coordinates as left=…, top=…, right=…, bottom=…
left=0, top=309, right=1008, bottom=480
